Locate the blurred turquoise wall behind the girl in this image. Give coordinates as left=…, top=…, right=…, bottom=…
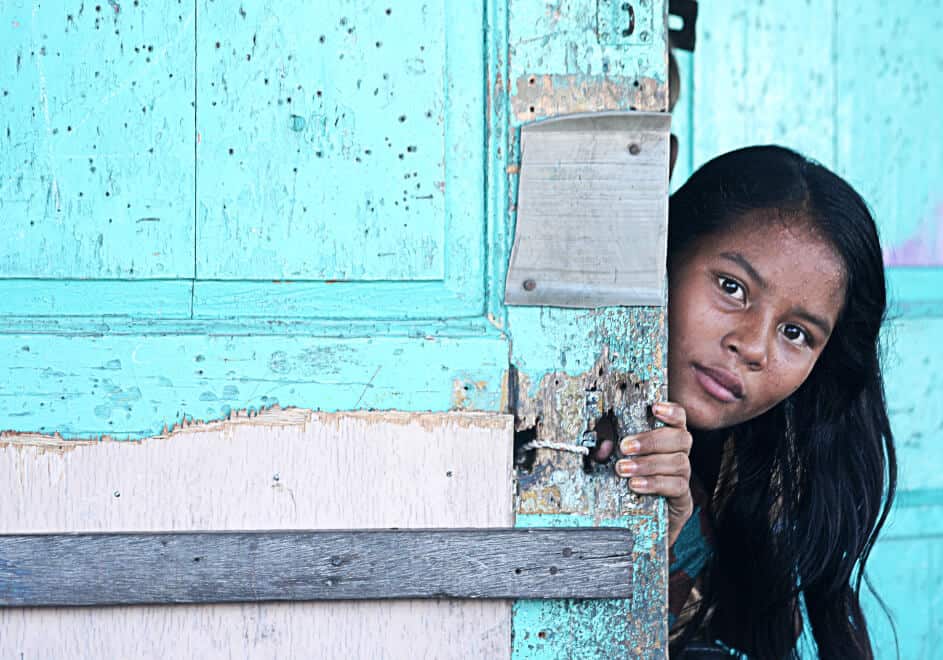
left=674, top=0, right=943, bottom=660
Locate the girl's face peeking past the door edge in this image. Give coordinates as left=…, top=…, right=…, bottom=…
left=668, top=211, right=845, bottom=430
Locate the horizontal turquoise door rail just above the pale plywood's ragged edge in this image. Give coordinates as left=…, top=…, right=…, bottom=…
left=0, top=320, right=507, bottom=438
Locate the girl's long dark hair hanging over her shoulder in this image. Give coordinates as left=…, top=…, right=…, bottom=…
left=668, top=146, right=897, bottom=659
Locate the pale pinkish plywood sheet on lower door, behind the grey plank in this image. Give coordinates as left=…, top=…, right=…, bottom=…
left=0, top=410, right=513, bottom=658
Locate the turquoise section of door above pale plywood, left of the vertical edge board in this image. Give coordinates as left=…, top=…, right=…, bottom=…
left=0, top=0, right=508, bottom=438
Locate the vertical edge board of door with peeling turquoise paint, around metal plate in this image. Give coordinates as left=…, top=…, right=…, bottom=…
left=502, top=0, right=668, bottom=659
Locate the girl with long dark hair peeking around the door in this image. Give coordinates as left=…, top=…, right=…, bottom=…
left=616, top=147, right=896, bottom=659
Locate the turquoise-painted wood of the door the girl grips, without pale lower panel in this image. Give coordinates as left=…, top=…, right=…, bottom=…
left=0, top=0, right=680, bottom=658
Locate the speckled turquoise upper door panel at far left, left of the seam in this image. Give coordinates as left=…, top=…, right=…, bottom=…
left=0, top=0, right=195, bottom=278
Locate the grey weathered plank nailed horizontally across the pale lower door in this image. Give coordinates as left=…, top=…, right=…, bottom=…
left=0, top=528, right=633, bottom=607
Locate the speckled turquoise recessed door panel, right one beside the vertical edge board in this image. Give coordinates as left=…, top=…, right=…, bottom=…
left=197, top=0, right=484, bottom=281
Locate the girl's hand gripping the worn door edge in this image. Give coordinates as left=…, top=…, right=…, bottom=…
left=616, top=401, right=694, bottom=547
